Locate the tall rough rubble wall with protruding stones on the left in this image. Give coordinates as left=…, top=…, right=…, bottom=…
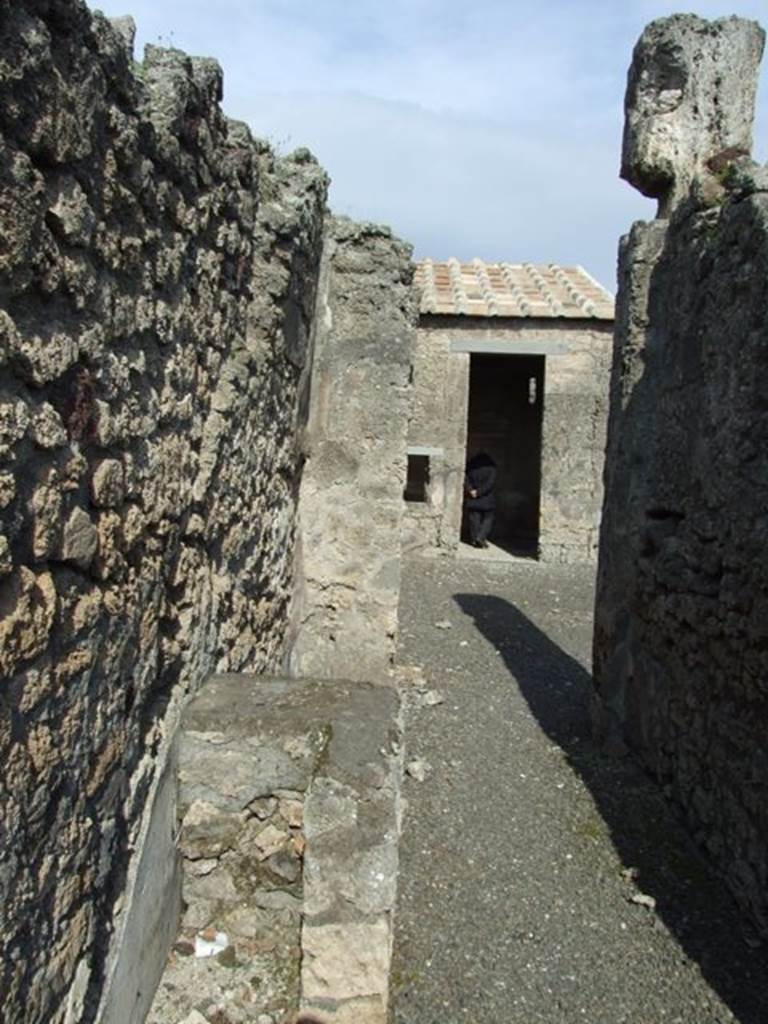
left=0, top=0, right=327, bottom=1024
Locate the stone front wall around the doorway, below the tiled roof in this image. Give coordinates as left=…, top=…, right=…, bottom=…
left=403, top=316, right=612, bottom=562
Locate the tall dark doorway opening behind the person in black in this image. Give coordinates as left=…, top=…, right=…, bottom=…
left=464, top=353, right=545, bottom=558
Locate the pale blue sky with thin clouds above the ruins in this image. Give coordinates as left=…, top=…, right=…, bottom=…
left=90, top=0, right=768, bottom=291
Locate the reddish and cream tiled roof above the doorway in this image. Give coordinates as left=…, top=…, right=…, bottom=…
left=415, top=259, right=613, bottom=319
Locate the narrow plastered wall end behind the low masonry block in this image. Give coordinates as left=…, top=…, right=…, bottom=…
left=291, top=218, right=416, bottom=681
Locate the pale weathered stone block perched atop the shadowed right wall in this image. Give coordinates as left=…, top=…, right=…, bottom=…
left=622, top=14, right=765, bottom=217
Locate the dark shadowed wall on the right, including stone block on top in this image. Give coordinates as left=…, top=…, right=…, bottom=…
left=595, top=16, right=768, bottom=933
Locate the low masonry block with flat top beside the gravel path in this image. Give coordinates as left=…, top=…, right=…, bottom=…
left=148, top=676, right=402, bottom=1024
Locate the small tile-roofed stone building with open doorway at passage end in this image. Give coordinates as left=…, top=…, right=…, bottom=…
left=403, top=259, right=613, bottom=562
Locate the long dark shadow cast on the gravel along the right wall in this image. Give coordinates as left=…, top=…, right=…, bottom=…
left=455, top=594, right=768, bottom=1024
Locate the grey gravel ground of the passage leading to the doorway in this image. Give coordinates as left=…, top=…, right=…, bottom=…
left=392, top=559, right=768, bottom=1024
